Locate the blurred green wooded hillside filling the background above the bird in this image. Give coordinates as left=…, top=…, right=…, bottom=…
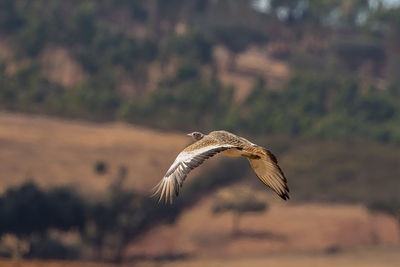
left=0, top=0, right=400, bottom=144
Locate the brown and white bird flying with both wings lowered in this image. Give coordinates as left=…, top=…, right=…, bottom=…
left=152, top=130, right=289, bottom=204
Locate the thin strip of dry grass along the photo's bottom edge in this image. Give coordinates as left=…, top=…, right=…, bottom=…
left=0, top=247, right=400, bottom=267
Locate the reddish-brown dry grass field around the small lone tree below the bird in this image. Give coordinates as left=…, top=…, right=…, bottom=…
left=130, top=193, right=399, bottom=257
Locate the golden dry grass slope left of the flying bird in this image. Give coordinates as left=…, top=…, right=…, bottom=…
left=0, top=112, right=190, bottom=196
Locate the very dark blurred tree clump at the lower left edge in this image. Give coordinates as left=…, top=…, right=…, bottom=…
left=0, top=182, right=87, bottom=259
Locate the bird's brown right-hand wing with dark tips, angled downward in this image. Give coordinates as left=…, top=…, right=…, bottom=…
left=243, top=147, right=289, bottom=200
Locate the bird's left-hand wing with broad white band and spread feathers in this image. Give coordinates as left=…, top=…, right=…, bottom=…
left=153, top=137, right=236, bottom=203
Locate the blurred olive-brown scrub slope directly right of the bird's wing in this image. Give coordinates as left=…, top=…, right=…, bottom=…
left=256, top=135, right=400, bottom=206
